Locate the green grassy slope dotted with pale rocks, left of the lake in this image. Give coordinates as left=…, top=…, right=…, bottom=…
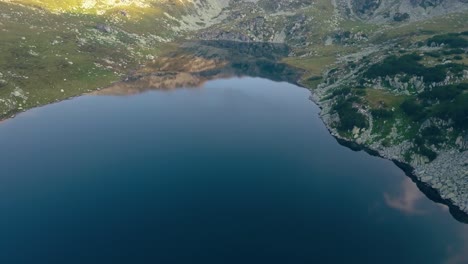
left=0, top=0, right=181, bottom=119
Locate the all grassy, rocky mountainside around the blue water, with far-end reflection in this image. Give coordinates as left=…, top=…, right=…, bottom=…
left=0, top=0, right=468, bottom=213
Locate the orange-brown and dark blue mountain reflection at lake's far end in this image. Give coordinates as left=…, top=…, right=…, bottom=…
left=93, top=41, right=301, bottom=95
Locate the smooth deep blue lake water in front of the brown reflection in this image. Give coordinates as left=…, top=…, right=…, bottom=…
left=0, top=78, right=468, bottom=264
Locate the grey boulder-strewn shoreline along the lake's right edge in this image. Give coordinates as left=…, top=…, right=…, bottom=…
left=310, top=90, right=468, bottom=223
